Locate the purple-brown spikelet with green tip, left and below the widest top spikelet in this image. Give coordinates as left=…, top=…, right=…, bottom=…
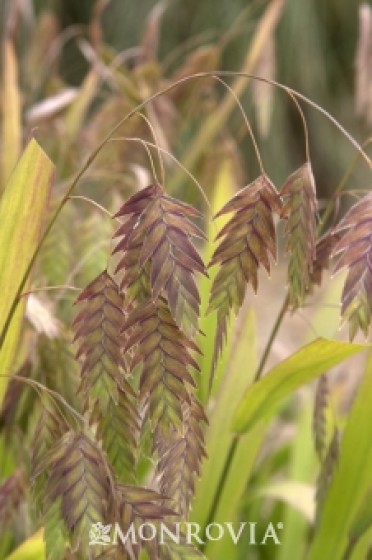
left=73, top=271, right=134, bottom=414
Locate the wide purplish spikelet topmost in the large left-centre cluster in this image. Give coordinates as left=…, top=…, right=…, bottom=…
left=114, top=184, right=206, bottom=336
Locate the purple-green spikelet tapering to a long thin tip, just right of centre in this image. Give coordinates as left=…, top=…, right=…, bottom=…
left=208, top=175, right=281, bottom=362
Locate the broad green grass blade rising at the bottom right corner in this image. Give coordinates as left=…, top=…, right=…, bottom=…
left=307, top=353, right=372, bottom=560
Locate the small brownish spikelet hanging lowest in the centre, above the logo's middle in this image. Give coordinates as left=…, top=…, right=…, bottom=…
left=154, top=398, right=207, bottom=519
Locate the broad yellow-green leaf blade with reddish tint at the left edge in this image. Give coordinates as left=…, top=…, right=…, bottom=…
left=0, top=139, right=54, bottom=401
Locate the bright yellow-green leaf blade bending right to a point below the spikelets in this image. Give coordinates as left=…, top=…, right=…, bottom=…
left=233, top=338, right=367, bottom=433
